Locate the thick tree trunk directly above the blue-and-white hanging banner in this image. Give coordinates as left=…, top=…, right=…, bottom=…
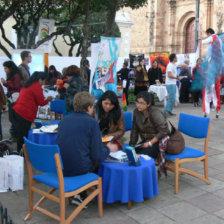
left=106, top=0, right=118, bottom=37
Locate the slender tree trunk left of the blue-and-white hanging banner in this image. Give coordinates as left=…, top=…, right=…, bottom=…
left=80, top=0, right=90, bottom=85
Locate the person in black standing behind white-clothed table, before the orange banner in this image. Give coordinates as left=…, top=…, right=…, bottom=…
left=148, top=60, right=163, bottom=85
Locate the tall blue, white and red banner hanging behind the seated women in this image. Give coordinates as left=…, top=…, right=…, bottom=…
left=92, top=37, right=121, bottom=99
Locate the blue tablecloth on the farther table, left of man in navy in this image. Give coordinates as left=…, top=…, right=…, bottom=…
left=28, top=129, right=58, bottom=145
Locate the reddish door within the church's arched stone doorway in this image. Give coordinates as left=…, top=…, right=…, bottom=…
left=185, top=18, right=195, bottom=53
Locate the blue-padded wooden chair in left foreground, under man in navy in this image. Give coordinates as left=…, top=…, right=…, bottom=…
left=23, top=137, right=103, bottom=224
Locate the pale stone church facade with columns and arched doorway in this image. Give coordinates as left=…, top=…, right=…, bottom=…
left=121, top=0, right=224, bottom=54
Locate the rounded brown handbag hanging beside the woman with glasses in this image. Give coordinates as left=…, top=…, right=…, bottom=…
left=166, top=121, right=185, bottom=155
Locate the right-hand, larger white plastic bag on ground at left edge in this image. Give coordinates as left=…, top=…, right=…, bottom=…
left=4, top=155, right=24, bottom=191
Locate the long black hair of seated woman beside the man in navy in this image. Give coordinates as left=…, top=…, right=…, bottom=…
left=96, top=90, right=121, bottom=134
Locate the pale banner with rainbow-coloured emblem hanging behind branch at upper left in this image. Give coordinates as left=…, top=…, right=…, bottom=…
left=37, top=18, right=55, bottom=53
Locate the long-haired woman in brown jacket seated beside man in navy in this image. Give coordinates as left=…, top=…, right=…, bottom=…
left=96, top=90, right=125, bottom=149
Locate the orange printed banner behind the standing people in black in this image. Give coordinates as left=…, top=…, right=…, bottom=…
left=149, top=52, right=169, bottom=74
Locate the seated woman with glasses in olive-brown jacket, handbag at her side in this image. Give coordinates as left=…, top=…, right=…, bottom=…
left=129, top=91, right=170, bottom=158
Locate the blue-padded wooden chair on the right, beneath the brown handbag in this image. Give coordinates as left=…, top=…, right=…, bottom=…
left=166, top=113, right=211, bottom=194
